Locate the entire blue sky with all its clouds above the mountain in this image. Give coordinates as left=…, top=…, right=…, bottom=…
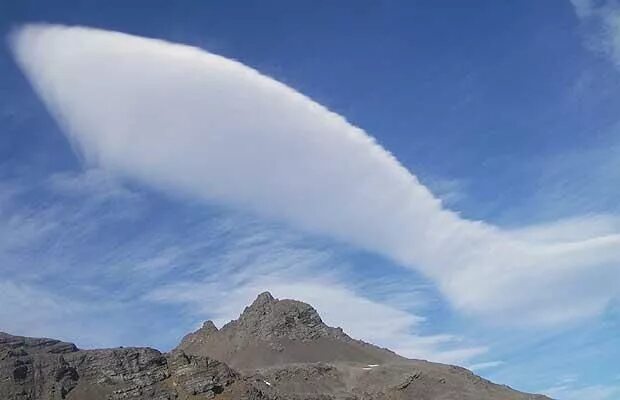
left=0, top=0, right=620, bottom=400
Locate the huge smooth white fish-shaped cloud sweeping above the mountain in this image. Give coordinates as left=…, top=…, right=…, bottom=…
left=10, top=25, right=620, bottom=323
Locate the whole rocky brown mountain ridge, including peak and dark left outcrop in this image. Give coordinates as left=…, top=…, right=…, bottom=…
left=0, top=293, right=548, bottom=400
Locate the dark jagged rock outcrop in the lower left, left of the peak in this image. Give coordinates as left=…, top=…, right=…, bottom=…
left=0, top=333, right=275, bottom=400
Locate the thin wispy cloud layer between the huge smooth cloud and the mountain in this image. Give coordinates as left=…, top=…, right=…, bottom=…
left=0, top=170, right=487, bottom=363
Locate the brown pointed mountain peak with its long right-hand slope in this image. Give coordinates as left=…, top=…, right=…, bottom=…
left=178, top=293, right=547, bottom=400
